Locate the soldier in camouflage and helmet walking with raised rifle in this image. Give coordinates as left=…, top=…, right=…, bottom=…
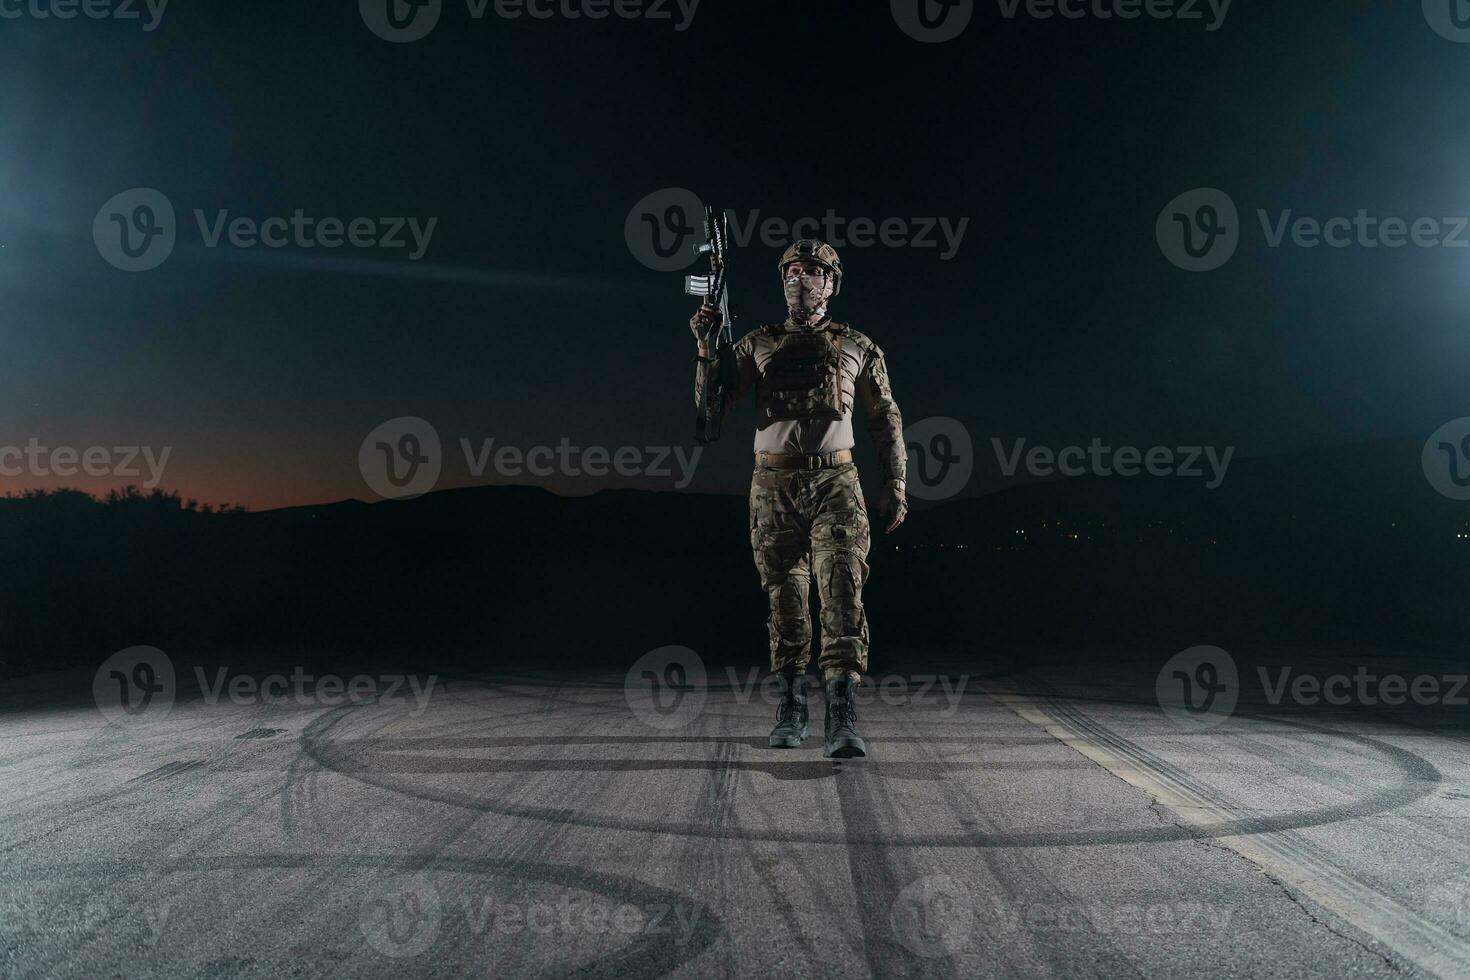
left=689, top=239, right=908, bottom=758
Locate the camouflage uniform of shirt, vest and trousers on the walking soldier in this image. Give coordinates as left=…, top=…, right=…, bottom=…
left=695, top=319, right=906, bottom=676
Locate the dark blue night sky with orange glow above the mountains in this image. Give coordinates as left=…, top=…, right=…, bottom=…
left=0, top=0, right=1470, bottom=508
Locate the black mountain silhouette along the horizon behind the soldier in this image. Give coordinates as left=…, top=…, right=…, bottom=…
left=0, top=441, right=1470, bottom=674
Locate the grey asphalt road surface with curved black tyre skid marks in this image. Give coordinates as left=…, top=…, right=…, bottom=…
left=0, top=651, right=1470, bottom=980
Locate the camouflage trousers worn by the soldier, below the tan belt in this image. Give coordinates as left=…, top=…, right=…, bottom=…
left=750, top=463, right=870, bottom=673
